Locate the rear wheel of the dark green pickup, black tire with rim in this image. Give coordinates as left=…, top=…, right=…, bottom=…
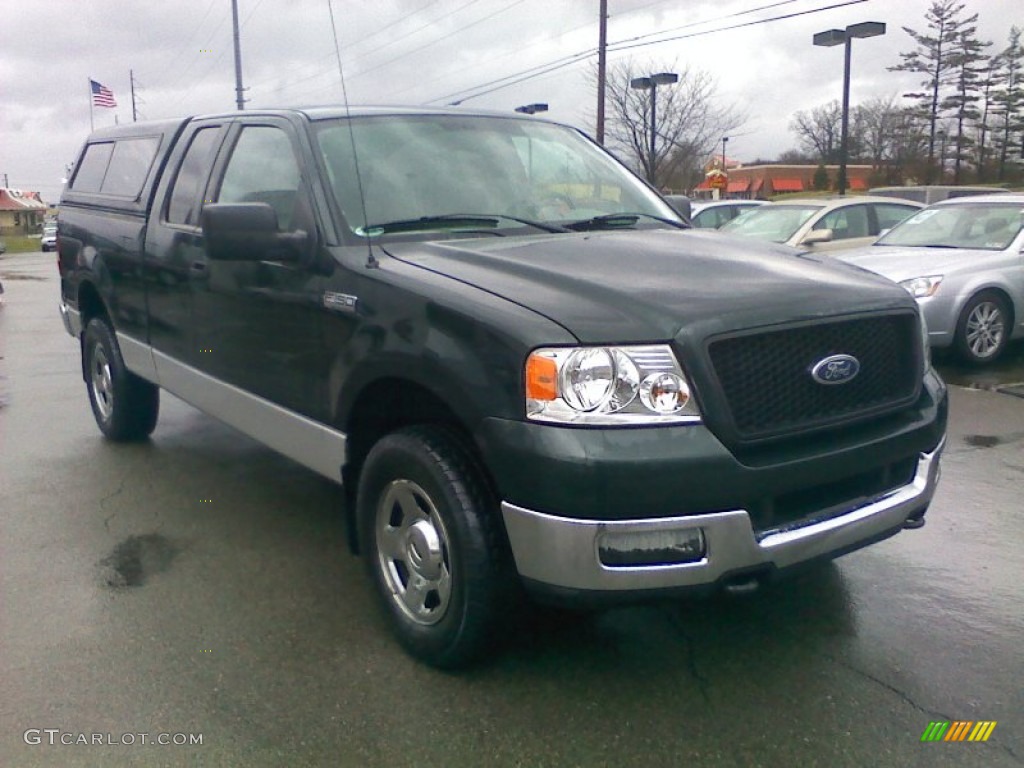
left=82, top=317, right=160, bottom=441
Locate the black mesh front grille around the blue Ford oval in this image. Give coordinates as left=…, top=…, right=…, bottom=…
left=708, top=313, right=921, bottom=440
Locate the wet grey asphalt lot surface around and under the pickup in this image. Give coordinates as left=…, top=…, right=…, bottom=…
left=0, top=254, right=1024, bottom=768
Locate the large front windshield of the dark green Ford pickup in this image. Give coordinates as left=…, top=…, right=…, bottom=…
left=316, top=115, right=679, bottom=237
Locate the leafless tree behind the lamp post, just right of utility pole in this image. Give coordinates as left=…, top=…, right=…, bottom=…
left=605, top=59, right=745, bottom=187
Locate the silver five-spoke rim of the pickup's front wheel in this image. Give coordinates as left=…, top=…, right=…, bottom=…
left=376, top=479, right=452, bottom=626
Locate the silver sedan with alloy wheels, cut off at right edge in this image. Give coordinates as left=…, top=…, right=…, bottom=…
left=840, top=194, right=1024, bottom=365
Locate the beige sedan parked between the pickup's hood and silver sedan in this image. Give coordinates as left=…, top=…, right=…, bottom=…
left=721, top=196, right=924, bottom=253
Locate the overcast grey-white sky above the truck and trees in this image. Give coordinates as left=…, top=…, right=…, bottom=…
left=0, top=0, right=1024, bottom=202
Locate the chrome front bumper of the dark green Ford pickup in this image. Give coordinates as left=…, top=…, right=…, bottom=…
left=502, top=439, right=945, bottom=592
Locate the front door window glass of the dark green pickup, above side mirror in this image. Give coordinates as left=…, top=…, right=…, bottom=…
left=217, top=125, right=300, bottom=231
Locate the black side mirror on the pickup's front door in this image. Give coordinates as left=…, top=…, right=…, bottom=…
left=202, top=203, right=309, bottom=261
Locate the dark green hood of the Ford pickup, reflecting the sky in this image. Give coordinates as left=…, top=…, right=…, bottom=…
left=383, top=229, right=914, bottom=343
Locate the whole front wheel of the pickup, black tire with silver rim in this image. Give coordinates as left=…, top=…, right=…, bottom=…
left=356, top=426, right=517, bottom=669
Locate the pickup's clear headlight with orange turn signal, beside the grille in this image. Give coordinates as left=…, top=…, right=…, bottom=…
left=525, top=344, right=700, bottom=426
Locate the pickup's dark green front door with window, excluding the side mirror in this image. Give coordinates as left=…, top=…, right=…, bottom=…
left=190, top=117, right=327, bottom=419
